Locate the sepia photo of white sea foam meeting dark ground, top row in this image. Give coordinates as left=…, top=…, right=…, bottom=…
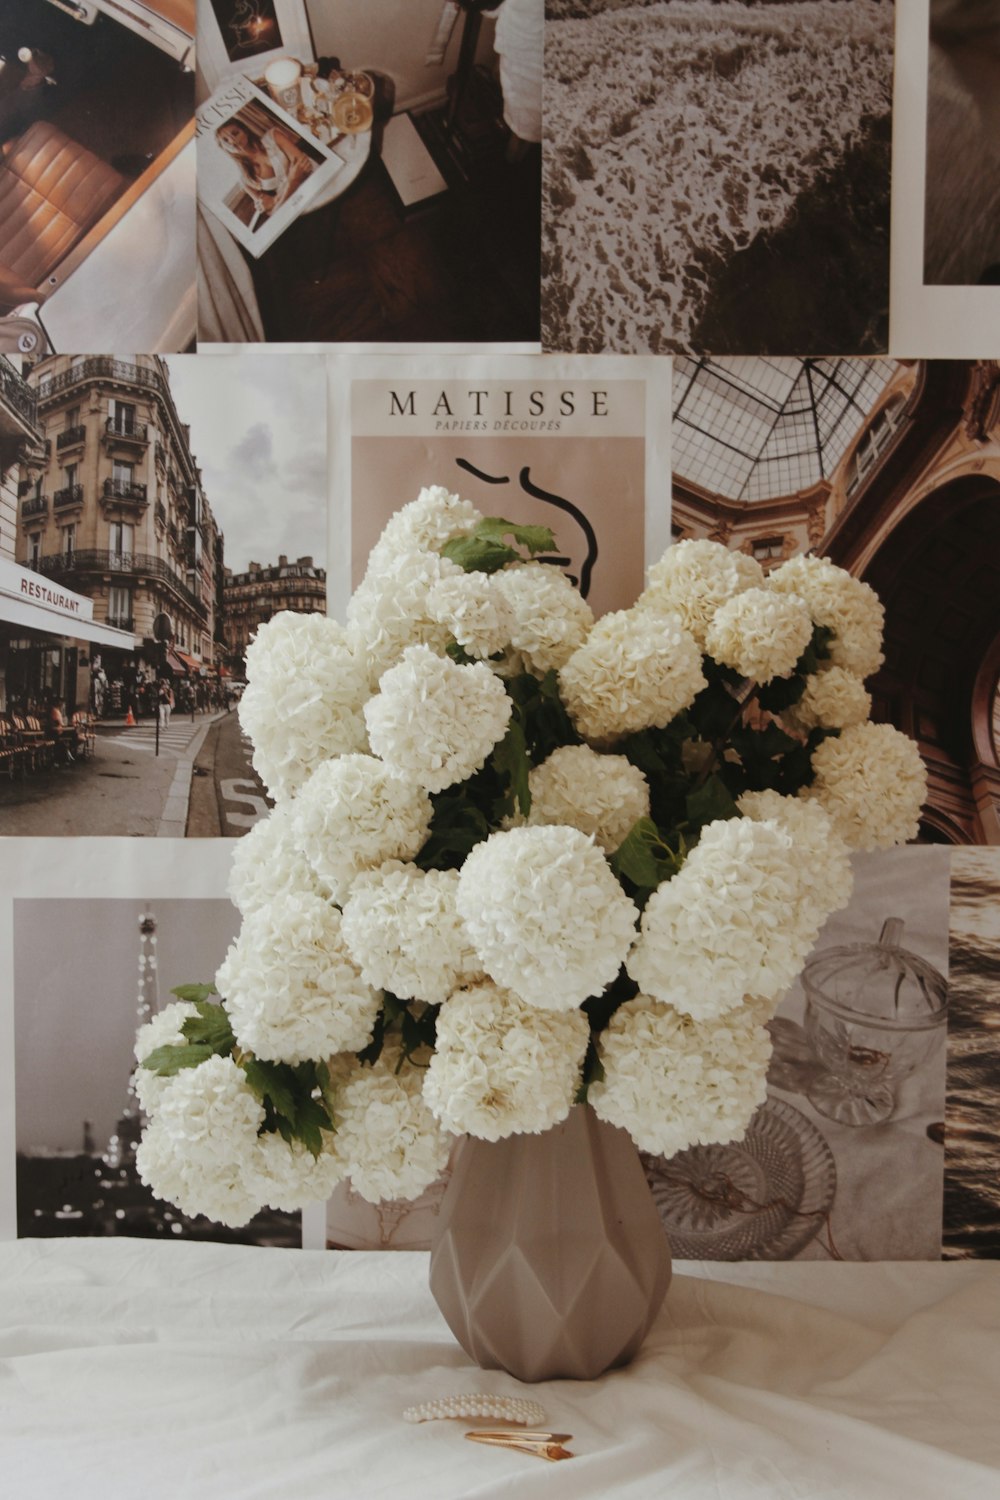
left=543, top=0, right=894, bottom=354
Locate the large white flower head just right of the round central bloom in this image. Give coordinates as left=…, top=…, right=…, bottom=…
left=628, top=818, right=822, bottom=1020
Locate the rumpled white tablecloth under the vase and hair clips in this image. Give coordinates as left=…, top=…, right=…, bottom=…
left=0, top=1239, right=1000, bottom=1500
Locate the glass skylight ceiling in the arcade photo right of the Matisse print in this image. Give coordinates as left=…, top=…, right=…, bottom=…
left=673, top=357, right=895, bottom=501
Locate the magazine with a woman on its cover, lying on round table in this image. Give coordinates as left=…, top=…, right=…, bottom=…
left=198, top=78, right=352, bottom=258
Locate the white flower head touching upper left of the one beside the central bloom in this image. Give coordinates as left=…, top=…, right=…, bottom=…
left=294, top=755, right=432, bottom=902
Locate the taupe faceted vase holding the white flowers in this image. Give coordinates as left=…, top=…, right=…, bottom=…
left=430, top=1106, right=670, bottom=1380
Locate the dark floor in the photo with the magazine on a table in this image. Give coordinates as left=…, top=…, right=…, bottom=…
left=255, top=119, right=541, bottom=344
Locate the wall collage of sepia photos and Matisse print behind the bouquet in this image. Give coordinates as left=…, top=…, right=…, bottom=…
left=0, top=0, right=1000, bottom=1260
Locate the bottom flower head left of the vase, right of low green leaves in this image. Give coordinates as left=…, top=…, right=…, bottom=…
left=333, top=1043, right=454, bottom=1203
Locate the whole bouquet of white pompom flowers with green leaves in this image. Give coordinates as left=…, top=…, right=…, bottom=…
left=136, top=488, right=925, bottom=1224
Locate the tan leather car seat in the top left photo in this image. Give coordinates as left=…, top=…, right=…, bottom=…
left=0, top=120, right=126, bottom=312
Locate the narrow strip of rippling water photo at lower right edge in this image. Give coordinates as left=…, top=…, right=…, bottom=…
left=943, top=849, right=1000, bottom=1260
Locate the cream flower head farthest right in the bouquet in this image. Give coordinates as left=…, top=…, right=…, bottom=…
left=799, top=725, right=927, bottom=849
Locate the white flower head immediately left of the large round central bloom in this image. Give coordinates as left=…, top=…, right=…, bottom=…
left=343, top=860, right=483, bottom=1005
